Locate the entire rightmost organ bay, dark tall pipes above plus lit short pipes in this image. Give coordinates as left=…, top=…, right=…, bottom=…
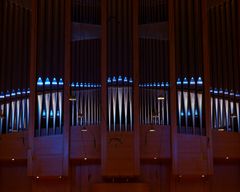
left=209, top=0, right=240, bottom=132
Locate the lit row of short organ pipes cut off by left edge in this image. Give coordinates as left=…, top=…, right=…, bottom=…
left=0, top=89, right=30, bottom=134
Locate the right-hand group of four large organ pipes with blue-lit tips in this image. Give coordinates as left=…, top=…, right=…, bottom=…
left=177, top=77, right=206, bottom=135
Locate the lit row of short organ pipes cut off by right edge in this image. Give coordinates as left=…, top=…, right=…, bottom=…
left=210, top=88, right=240, bottom=132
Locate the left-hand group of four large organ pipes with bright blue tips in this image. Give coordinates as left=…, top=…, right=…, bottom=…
left=35, top=77, right=63, bottom=136
